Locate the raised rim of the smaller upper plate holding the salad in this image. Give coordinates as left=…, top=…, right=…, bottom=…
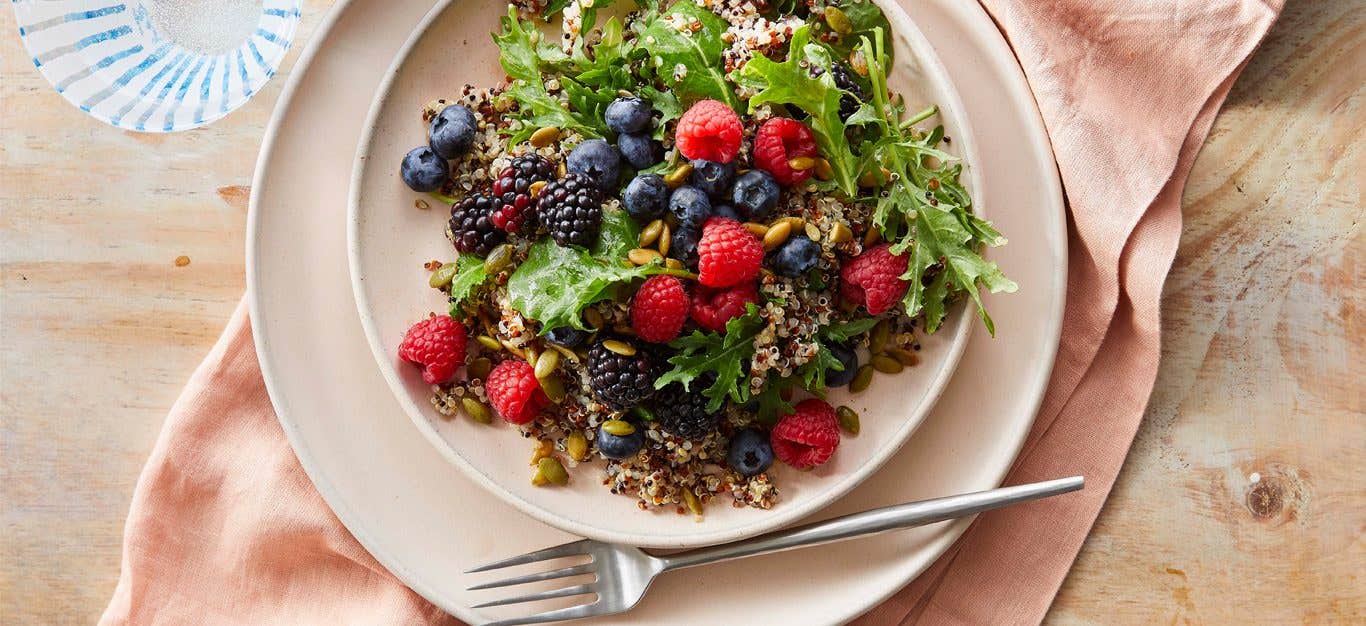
left=347, top=0, right=983, bottom=548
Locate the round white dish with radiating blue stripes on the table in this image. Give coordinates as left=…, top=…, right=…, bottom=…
left=12, top=0, right=301, bottom=133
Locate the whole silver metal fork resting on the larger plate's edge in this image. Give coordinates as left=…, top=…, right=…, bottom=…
left=466, top=476, right=1083, bottom=626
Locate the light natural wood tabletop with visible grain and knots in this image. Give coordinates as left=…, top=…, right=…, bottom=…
left=0, top=0, right=1366, bottom=623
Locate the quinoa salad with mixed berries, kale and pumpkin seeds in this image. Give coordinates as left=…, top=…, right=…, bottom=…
left=399, top=0, right=1016, bottom=517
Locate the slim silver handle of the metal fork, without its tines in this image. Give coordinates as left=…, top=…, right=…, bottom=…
left=660, top=476, right=1085, bottom=571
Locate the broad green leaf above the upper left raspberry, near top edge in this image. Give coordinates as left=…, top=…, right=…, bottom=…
left=637, top=0, right=740, bottom=111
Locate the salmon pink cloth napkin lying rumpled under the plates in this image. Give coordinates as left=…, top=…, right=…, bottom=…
left=101, top=0, right=1281, bottom=625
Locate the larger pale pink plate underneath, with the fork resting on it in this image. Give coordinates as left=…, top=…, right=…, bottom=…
left=247, top=0, right=1065, bottom=625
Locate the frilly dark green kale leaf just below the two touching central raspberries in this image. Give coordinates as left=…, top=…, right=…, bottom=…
left=654, top=303, right=764, bottom=411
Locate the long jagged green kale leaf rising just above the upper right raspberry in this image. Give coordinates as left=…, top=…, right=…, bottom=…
left=731, top=26, right=859, bottom=198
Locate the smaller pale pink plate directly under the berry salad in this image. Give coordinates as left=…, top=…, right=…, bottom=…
left=348, top=0, right=981, bottom=548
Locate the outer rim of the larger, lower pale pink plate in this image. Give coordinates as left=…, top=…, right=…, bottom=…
left=246, top=0, right=1068, bottom=622
